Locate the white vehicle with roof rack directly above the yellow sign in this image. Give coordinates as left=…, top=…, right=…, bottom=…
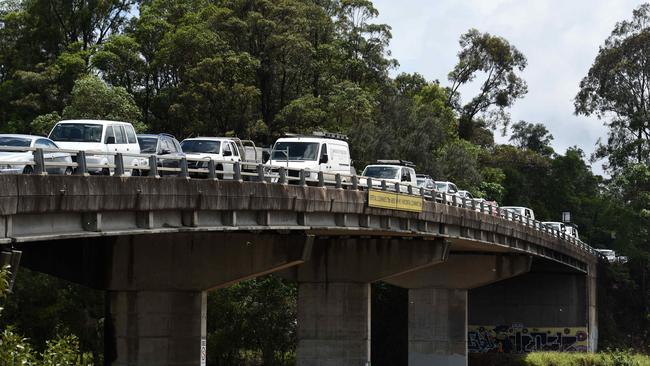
left=360, top=160, right=418, bottom=193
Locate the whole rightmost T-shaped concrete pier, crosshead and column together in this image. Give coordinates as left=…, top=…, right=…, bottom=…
left=386, top=253, right=531, bottom=366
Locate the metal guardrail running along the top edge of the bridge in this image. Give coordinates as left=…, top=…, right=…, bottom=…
left=0, top=146, right=604, bottom=257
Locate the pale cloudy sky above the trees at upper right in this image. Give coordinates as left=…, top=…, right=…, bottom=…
left=373, top=0, right=641, bottom=174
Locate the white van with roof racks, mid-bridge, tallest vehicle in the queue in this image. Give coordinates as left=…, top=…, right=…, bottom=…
left=266, top=132, right=352, bottom=181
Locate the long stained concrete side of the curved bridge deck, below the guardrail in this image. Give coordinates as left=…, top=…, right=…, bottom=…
left=0, top=175, right=595, bottom=272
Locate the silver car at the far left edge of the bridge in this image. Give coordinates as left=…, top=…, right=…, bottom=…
left=0, top=134, right=73, bottom=175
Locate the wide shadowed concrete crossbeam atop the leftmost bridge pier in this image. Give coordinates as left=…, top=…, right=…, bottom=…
left=21, top=232, right=313, bottom=291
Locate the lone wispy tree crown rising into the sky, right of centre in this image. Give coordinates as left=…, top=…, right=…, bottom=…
left=447, top=29, right=528, bottom=140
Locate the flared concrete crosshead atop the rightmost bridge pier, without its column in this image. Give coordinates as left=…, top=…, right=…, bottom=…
left=385, top=253, right=532, bottom=289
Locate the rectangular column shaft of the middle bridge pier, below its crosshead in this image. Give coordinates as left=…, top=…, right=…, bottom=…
left=296, top=282, right=370, bottom=366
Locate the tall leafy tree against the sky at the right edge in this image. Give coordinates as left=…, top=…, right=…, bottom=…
left=575, top=4, right=650, bottom=175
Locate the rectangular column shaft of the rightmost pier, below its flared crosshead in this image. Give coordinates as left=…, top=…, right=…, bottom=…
left=409, top=288, right=467, bottom=366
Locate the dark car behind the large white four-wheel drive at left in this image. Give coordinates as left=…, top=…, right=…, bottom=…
left=138, top=133, right=185, bottom=175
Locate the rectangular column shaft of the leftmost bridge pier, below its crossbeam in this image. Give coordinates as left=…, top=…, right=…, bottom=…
left=105, top=291, right=207, bottom=366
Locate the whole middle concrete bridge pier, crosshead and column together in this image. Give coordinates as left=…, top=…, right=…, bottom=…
left=280, top=238, right=448, bottom=366
